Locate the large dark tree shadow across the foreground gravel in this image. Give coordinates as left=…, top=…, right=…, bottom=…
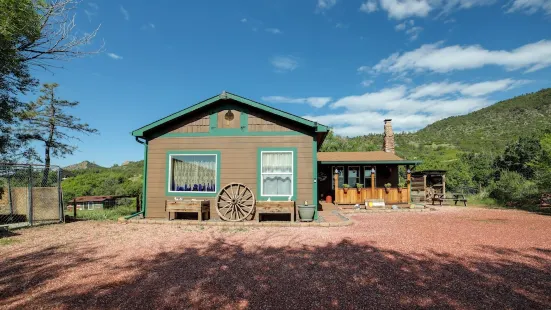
left=0, top=240, right=551, bottom=309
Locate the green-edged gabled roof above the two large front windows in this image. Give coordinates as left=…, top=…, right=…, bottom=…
left=132, top=92, right=329, bottom=137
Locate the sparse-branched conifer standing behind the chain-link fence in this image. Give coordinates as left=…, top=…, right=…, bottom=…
left=20, top=83, right=97, bottom=184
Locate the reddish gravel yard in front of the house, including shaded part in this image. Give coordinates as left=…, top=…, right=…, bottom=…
left=0, top=209, right=551, bottom=309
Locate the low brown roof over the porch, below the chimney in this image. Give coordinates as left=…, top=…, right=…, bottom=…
left=318, top=151, right=420, bottom=165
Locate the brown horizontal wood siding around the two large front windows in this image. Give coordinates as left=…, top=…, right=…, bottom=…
left=147, top=135, right=314, bottom=218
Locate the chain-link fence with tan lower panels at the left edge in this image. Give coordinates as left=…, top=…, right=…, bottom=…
left=0, top=163, right=63, bottom=227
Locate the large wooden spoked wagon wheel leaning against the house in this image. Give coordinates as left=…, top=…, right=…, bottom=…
left=216, top=183, right=255, bottom=222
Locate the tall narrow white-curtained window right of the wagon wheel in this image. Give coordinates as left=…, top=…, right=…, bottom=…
left=260, top=151, right=294, bottom=197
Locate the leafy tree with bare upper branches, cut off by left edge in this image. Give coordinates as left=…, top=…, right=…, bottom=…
left=0, top=0, right=102, bottom=161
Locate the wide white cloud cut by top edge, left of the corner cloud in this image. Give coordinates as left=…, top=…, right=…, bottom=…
left=360, top=0, right=498, bottom=20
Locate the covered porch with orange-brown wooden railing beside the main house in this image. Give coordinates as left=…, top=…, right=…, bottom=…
left=318, top=151, right=420, bottom=205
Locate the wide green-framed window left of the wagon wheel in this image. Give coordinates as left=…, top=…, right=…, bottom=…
left=168, top=154, right=219, bottom=194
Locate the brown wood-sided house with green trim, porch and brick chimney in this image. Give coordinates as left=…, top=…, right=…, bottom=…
left=132, top=92, right=418, bottom=218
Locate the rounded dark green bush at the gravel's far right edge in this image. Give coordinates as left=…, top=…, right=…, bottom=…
left=490, top=170, right=538, bottom=206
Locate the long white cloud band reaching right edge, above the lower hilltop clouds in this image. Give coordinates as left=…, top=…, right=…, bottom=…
left=366, top=40, right=551, bottom=74
